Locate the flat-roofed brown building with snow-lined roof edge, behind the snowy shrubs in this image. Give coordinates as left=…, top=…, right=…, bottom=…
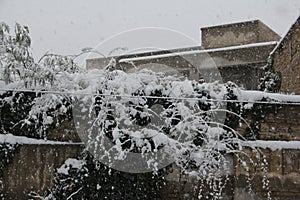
left=86, top=20, right=280, bottom=89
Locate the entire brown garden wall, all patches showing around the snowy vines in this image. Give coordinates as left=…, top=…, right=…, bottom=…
left=3, top=106, right=300, bottom=200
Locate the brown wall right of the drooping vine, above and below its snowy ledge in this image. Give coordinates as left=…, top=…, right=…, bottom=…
left=234, top=105, right=300, bottom=200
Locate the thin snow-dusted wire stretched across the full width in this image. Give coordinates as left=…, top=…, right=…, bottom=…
left=0, top=89, right=300, bottom=106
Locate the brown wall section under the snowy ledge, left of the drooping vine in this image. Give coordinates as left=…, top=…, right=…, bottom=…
left=3, top=144, right=83, bottom=200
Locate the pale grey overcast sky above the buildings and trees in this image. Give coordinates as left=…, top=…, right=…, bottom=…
left=0, top=0, right=300, bottom=58
